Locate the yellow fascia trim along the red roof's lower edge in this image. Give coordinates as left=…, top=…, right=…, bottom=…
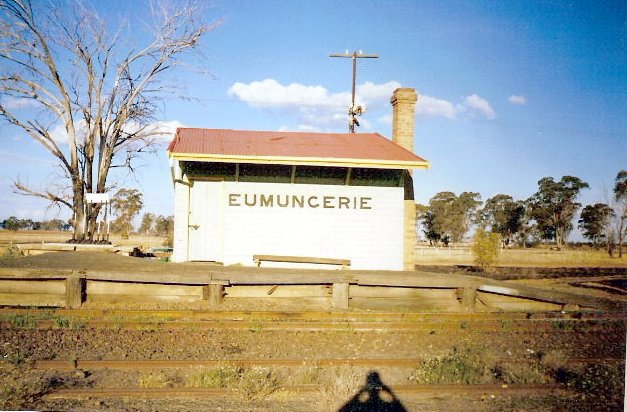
left=168, top=152, right=430, bottom=169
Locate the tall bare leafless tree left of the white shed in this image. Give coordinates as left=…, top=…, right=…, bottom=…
left=0, top=0, right=218, bottom=240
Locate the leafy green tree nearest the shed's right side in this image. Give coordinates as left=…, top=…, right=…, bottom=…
left=418, top=192, right=481, bottom=244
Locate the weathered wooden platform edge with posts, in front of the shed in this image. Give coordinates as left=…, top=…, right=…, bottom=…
left=0, top=264, right=627, bottom=312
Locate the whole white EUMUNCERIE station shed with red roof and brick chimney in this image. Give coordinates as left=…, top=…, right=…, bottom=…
left=168, top=88, right=429, bottom=270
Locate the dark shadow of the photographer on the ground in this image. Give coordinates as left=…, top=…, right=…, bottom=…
left=338, top=371, right=407, bottom=412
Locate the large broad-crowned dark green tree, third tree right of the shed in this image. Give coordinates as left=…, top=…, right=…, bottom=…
left=528, top=176, right=590, bottom=249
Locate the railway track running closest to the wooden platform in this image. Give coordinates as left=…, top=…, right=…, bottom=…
left=0, top=309, right=627, bottom=333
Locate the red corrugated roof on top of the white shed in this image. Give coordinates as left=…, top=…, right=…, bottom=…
left=168, top=128, right=428, bottom=167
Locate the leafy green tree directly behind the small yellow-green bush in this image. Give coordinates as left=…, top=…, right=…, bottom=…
left=481, top=194, right=525, bottom=246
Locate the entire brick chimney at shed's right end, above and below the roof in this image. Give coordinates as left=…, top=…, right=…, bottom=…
left=390, top=88, right=418, bottom=271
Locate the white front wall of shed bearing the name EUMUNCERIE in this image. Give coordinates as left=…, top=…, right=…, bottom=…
left=174, top=182, right=403, bottom=270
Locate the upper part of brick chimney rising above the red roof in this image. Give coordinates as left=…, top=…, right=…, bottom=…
left=390, top=88, right=418, bottom=153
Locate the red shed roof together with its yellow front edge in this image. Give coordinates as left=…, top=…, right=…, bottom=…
left=168, top=128, right=429, bottom=169
